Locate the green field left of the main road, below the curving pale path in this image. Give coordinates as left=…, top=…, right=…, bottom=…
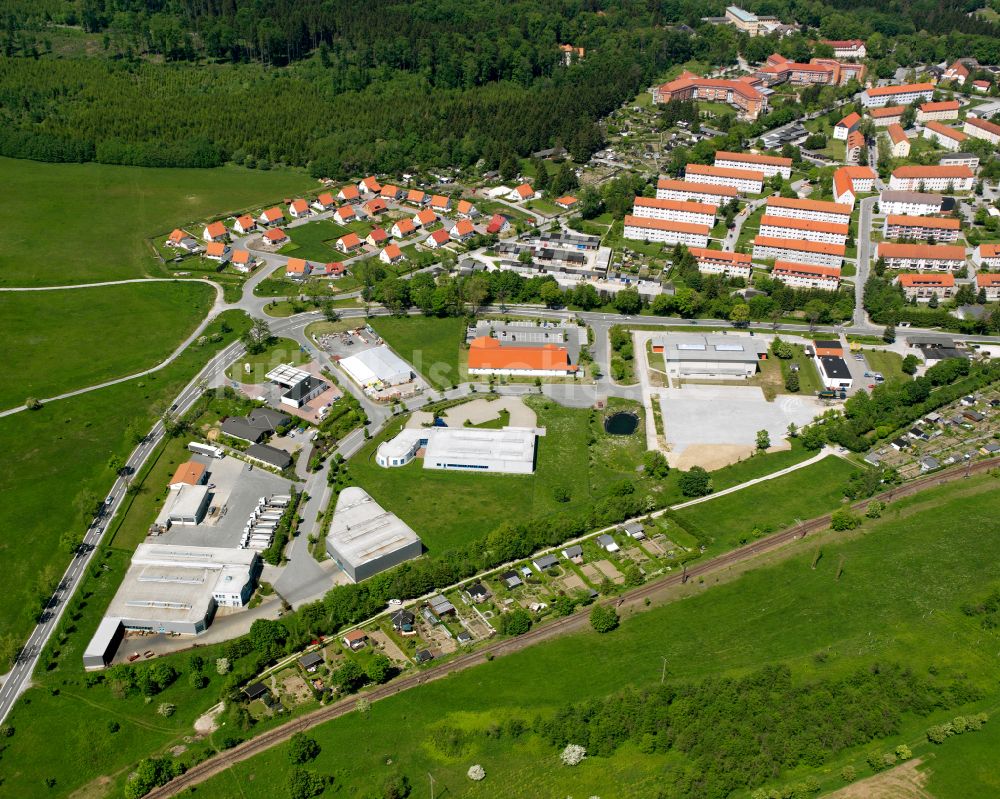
left=0, top=310, right=246, bottom=646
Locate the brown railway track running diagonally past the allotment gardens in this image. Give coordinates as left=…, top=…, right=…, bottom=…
left=146, top=458, right=1000, bottom=799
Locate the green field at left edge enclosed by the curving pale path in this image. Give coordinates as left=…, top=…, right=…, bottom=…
left=0, top=282, right=215, bottom=408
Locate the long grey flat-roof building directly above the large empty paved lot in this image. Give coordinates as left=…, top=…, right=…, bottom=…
left=653, top=333, right=767, bottom=379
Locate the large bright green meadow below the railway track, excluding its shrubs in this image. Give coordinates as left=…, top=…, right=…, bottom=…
left=180, top=478, right=1000, bottom=799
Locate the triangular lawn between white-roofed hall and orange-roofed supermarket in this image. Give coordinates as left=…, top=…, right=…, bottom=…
left=369, top=316, right=465, bottom=388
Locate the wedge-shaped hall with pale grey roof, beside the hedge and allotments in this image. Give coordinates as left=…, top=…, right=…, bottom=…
left=326, top=486, right=423, bottom=583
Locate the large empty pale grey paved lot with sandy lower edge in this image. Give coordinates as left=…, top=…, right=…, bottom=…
left=660, top=385, right=824, bottom=468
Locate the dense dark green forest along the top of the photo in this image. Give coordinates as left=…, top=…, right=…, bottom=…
left=0, top=0, right=1000, bottom=172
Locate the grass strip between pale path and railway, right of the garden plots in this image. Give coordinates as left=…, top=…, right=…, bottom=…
left=677, top=457, right=857, bottom=551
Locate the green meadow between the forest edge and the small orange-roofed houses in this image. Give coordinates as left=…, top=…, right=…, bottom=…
left=0, top=158, right=313, bottom=286
